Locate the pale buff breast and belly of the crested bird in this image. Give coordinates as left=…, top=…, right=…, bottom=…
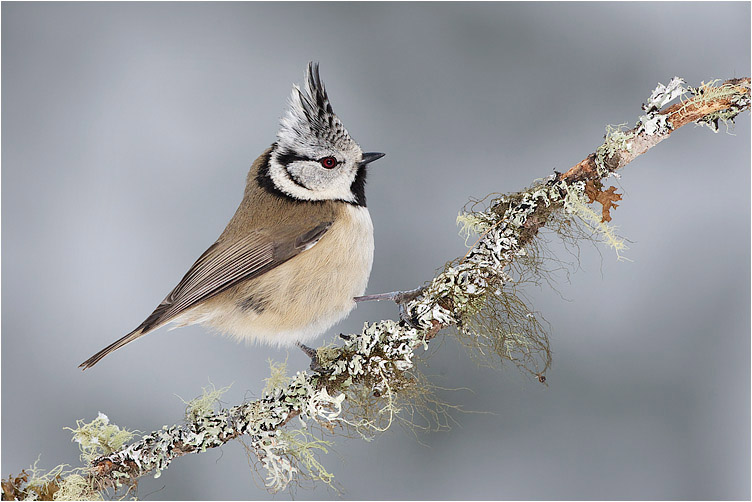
left=179, top=206, right=373, bottom=345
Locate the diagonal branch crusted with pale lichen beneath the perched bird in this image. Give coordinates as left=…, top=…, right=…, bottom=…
left=3, top=78, right=750, bottom=498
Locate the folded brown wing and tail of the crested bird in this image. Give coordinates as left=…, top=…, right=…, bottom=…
left=79, top=221, right=332, bottom=369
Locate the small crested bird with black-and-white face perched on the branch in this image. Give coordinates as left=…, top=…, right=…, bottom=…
left=79, top=62, right=384, bottom=369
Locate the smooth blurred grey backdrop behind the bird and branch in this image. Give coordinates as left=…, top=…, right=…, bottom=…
left=2, top=2, right=750, bottom=500
